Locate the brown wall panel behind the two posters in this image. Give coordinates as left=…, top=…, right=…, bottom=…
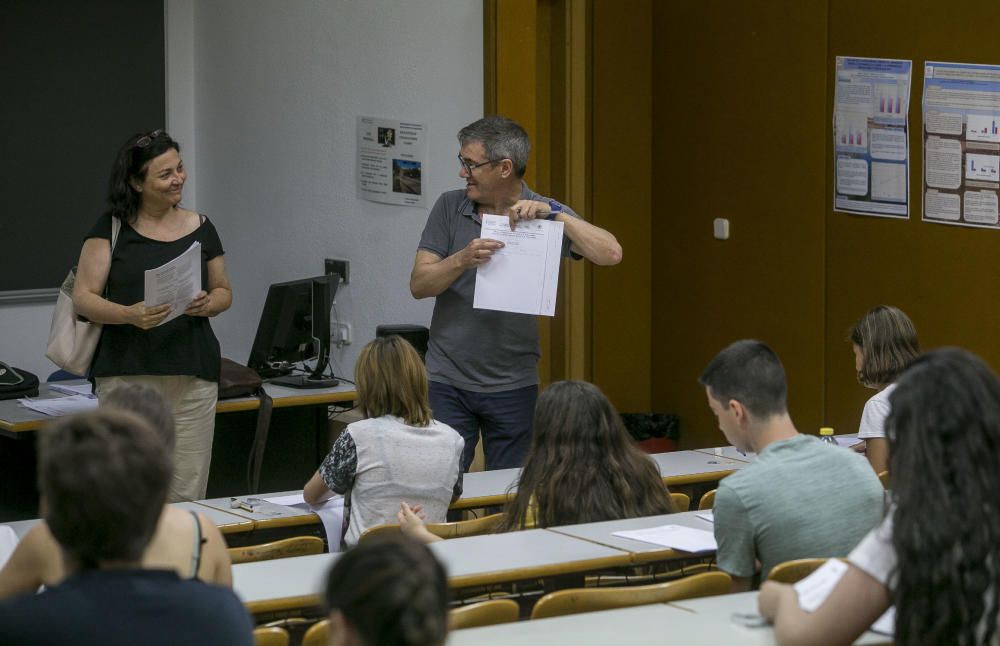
left=825, top=0, right=1000, bottom=432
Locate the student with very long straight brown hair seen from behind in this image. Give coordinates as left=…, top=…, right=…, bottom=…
left=398, top=381, right=676, bottom=542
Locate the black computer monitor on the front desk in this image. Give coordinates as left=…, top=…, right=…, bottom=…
left=247, top=274, right=340, bottom=388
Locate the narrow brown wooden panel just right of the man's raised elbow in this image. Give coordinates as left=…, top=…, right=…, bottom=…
left=591, top=0, right=653, bottom=411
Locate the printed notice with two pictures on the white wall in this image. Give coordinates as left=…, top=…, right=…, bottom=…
left=358, top=117, right=427, bottom=206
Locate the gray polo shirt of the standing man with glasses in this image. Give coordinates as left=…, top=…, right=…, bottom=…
left=419, top=184, right=578, bottom=392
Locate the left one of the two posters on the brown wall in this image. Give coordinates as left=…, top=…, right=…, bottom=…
left=833, top=56, right=912, bottom=218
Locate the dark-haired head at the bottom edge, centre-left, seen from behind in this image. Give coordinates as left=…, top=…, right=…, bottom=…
left=326, top=534, right=448, bottom=646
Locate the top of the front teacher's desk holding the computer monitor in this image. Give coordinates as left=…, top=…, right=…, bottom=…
left=0, top=380, right=356, bottom=437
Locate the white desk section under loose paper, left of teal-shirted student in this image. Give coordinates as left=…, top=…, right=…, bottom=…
left=549, top=511, right=714, bottom=564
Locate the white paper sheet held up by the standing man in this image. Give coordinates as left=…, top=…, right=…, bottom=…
left=472, top=214, right=563, bottom=316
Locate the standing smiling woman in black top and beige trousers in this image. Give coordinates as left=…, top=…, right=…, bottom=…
left=73, top=130, right=232, bottom=501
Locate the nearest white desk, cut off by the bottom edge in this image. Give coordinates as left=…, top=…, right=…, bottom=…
left=447, top=592, right=890, bottom=646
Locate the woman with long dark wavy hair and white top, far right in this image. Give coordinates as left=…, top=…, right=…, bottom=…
left=758, top=348, right=1000, bottom=646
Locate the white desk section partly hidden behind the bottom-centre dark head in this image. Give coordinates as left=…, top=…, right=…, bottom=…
left=233, top=529, right=630, bottom=616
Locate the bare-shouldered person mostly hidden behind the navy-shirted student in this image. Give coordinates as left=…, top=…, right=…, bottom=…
left=0, top=384, right=233, bottom=599
